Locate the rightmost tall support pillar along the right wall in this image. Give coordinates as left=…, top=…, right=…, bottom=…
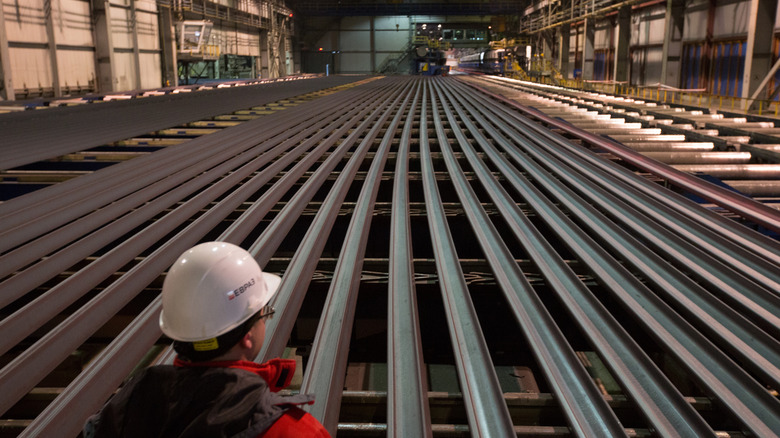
left=742, top=0, right=777, bottom=109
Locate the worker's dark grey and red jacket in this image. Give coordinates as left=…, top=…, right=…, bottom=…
left=84, top=359, right=330, bottom=438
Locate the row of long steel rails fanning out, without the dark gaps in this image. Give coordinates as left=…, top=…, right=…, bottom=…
left=0, top=78, right=780, bottom=437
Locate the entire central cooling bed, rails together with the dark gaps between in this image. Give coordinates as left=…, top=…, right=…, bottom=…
left=0, top=77, right=780, bottom=437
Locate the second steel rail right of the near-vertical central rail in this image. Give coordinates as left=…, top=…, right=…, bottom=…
left=433, top=82, right=632, bottom=437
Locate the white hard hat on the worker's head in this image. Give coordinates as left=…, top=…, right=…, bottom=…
left=160, top=242, right=282, bottom=342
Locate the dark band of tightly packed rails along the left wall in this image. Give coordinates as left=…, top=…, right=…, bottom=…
left=0, top=76, right=364, bottom=169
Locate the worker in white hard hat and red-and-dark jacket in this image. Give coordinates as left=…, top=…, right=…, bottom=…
left=84, top=242, right=330, bottom=438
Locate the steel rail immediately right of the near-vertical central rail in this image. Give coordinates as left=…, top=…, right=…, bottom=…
left=420, top=80, right=515, bottom=437
